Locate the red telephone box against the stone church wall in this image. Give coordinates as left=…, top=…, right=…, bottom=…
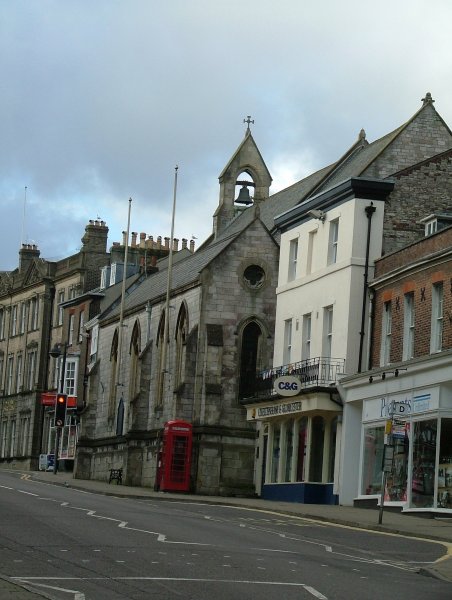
left=160, top=421, right=193, bottom=492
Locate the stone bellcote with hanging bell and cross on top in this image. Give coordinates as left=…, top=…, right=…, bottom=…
left=213, top=116, right=272, bottom=237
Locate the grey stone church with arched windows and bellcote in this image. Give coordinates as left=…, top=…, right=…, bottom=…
left=75, top=130, right=279, bottom=495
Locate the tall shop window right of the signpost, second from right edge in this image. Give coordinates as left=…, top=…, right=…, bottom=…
left=411, top=419, right=437, bottom=508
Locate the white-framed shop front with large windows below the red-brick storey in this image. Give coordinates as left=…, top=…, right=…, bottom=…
left=357, top=386, right=452, bottom=511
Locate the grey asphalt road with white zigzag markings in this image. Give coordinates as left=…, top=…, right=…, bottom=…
left=0, top=472, right=452, bottom=600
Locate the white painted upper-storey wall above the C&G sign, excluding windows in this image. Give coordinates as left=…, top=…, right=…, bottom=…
left=273, top=198, right=384, bottom=373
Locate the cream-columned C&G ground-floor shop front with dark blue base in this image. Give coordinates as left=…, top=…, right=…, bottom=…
left=247, top=392, right=342, bottom=504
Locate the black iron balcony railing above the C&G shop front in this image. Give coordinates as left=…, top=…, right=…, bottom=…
left=240, top=357, right=345, bottom=400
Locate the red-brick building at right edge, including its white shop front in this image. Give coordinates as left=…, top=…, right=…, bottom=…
left=341, top=218, right=452, bottom=512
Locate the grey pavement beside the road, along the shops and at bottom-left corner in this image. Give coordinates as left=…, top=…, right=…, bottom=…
left=0, top=471, right=452, bottom=600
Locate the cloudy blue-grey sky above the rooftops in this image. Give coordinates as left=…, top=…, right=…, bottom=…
left=0, top=0, right=452, bottom=271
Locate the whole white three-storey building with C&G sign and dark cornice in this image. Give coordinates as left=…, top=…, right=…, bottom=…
left=242, top=178, right=393, bottom=503
